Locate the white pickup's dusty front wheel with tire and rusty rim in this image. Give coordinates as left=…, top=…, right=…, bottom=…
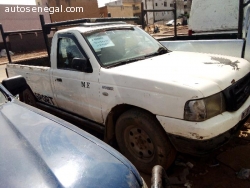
left=116, top=108, right=176, bottom=174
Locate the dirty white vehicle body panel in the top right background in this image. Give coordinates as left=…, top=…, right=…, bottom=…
left=188, top=0, right=239, bottom=35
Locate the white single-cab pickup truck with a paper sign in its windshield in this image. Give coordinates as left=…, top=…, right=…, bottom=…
left=4, top=19, right=250, bottom=173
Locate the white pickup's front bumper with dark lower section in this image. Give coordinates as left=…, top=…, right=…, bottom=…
left=157, top=97, right=250, bottom=155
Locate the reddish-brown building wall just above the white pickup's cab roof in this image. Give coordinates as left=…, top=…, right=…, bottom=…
left=48, top=0, right=100, bottom=22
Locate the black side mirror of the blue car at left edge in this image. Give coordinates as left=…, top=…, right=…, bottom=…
left=2, top=76, right=28, bottom=96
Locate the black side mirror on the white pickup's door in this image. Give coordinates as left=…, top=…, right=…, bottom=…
left=71, top=58, right=93, bottom=73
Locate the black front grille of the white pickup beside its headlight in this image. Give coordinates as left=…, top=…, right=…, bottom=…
left=222, top=73, right=250, bottom=112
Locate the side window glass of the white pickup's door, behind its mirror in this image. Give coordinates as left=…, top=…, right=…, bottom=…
left=57, top=38, right=84, bottom=70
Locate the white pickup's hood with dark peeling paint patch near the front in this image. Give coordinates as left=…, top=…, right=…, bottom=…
left=101, top=52, right=250, bottom=97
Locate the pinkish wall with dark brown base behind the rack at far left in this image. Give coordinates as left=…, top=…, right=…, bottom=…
left=0, top=5, right=50, bottom=52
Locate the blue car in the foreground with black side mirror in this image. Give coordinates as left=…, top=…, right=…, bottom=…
left=0, top=77, right=146, bottom=188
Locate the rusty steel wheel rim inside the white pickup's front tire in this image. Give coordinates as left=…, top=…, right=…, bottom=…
left=126, top=126, right=154, bottom=162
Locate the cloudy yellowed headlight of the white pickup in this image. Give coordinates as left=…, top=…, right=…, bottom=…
left=184, top=93, right=226, bottom=121
